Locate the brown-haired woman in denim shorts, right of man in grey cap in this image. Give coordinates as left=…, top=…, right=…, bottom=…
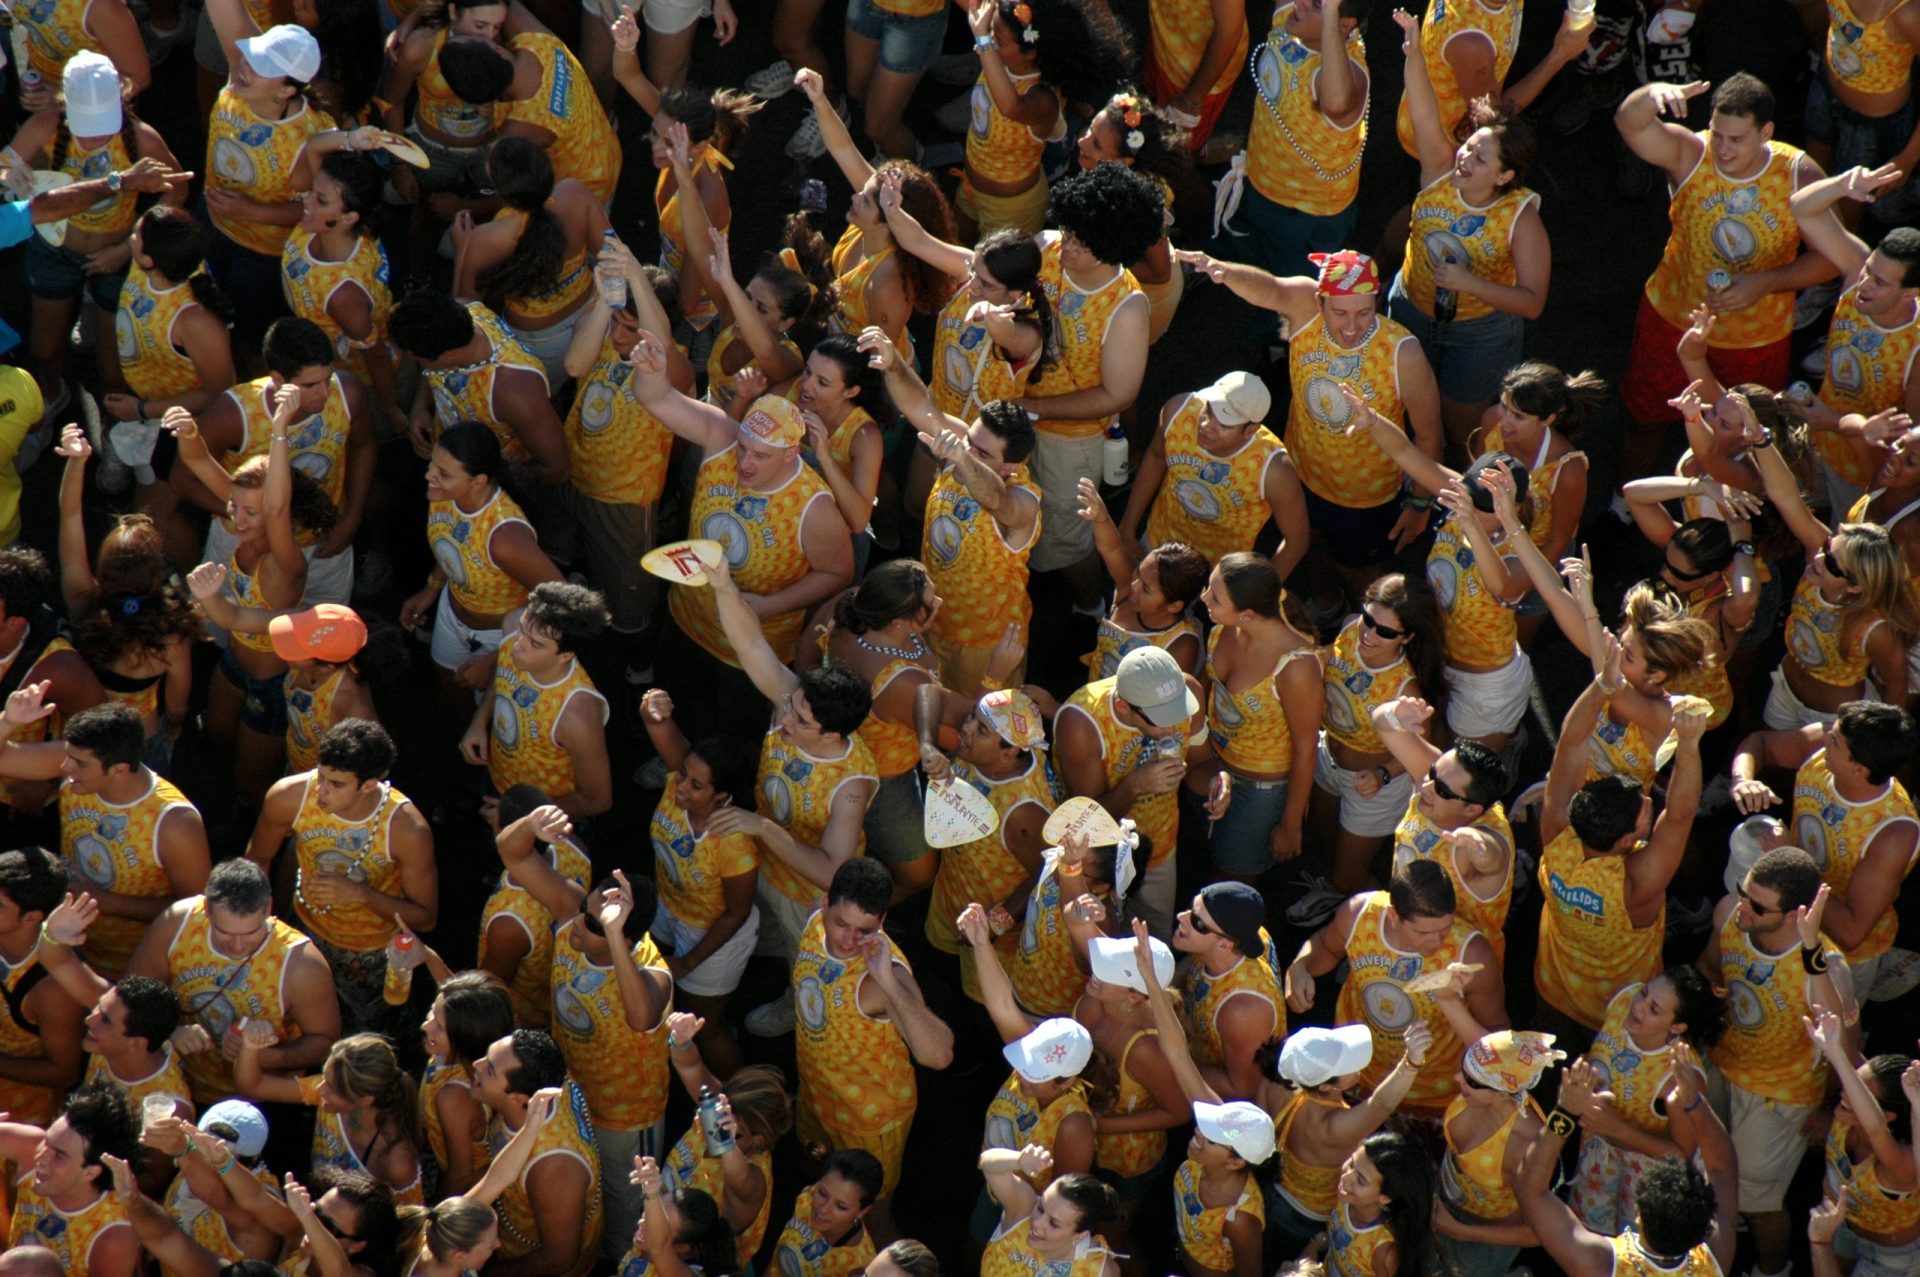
left=1187, top=551, right=1327, bottom=879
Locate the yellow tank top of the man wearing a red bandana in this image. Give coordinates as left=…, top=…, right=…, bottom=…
left=1290, top=311, right=1413, bottom=509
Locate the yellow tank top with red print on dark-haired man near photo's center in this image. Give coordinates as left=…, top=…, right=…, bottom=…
left=920, top=465, right=1041, bottom=647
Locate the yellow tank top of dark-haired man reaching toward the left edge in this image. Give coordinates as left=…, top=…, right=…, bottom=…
left=60, top=772, right=192, bottom=979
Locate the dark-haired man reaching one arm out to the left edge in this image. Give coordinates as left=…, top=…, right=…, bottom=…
left=0, top=698, right=211, bottom=976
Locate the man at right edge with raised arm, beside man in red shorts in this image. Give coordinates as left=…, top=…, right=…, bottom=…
left=1788, top=168, right=1920, bottom=509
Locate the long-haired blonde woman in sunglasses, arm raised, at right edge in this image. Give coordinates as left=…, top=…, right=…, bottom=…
left=1730, top=396, right=1920, bottom=730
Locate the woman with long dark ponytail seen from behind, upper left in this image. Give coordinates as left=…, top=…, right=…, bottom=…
left=453, top=136, right=611, bottom=386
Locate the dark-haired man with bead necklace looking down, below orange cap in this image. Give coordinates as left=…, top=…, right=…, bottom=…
left=248, top=718, right=440, bottom=1033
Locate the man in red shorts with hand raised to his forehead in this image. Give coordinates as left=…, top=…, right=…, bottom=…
left=1615, top=71, right=1834, bottom=478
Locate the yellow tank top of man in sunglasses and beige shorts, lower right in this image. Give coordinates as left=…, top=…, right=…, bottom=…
left=1713, top=914, right=1845, bottom=1104
